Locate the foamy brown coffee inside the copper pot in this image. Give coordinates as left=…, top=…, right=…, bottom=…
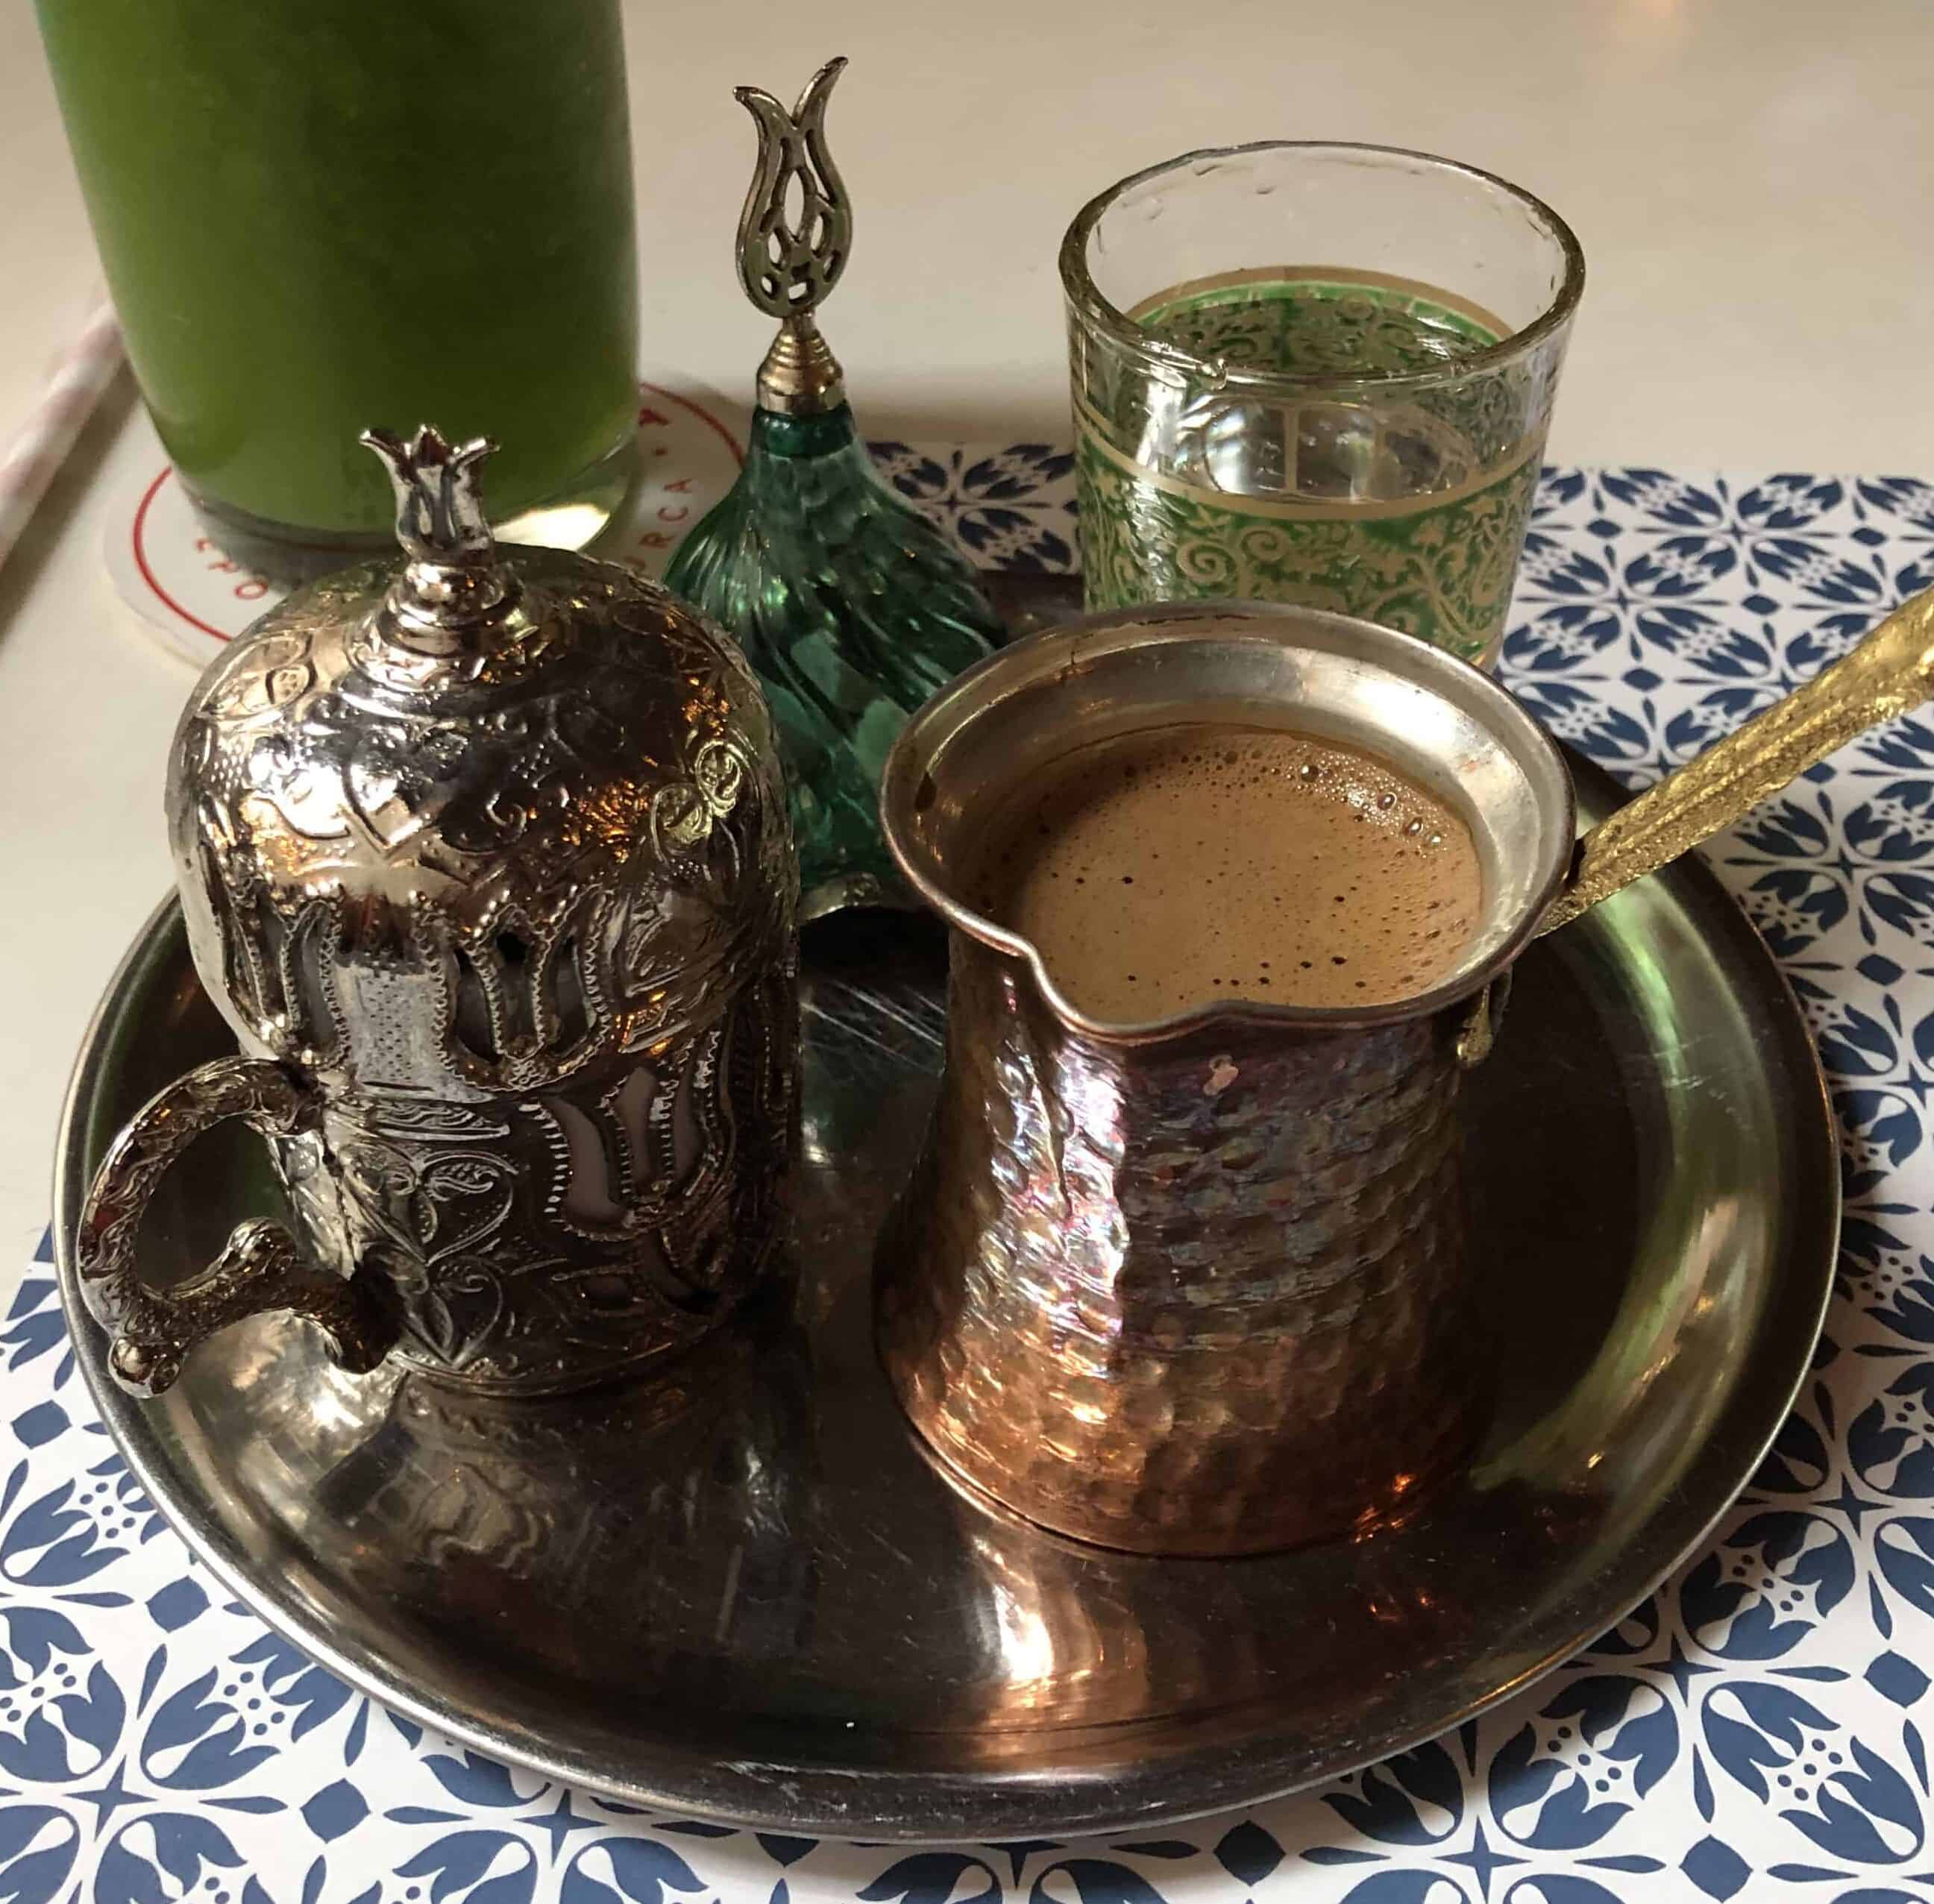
left=975, top=723, right=1484, bottom=1021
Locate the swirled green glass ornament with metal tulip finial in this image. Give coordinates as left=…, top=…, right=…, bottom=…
left=665, top=60, right=1000, bottom=918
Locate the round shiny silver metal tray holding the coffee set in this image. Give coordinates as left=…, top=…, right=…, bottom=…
left=56, top=764, right=1837, bottom=1840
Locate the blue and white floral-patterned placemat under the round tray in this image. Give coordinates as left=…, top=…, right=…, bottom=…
left=11, top=459, right=1934, bottom=1904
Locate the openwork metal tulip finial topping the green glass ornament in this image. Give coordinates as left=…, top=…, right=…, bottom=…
left=733, top=60, right=853, bottom=415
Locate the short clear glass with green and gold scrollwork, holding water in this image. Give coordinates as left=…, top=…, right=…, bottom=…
left=1060, top=141, right=1584, bottom=665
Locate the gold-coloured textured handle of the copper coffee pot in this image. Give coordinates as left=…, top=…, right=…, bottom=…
left=1537, top=590, right=1934, bottom=934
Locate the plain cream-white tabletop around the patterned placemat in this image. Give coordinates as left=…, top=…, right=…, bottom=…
left=0, top=0, right=1934, bottom=1281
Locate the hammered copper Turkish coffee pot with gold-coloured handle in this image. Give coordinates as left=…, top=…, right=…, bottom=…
left=878, top=594, right=1934, bottom=1554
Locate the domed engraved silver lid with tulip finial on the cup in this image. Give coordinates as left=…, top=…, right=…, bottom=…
left=169, top=427, right=795, bottom=1096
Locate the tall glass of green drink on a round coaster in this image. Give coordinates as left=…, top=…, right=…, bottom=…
left=39, top=0, right=638, bottom=576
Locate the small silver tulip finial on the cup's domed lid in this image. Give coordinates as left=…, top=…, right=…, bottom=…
left=360, top=424, right=516, bottom=647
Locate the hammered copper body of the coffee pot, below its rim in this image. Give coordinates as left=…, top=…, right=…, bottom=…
left=878, top=934, right=1480, bottom=1554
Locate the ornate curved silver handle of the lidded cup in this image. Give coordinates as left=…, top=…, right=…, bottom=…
left=74, top=1058, right=389, bottom=1400
